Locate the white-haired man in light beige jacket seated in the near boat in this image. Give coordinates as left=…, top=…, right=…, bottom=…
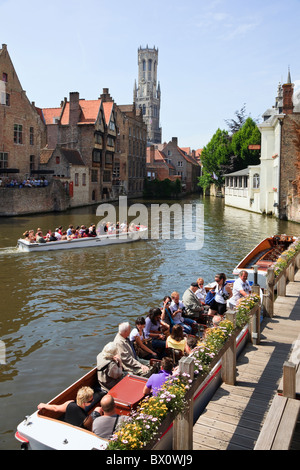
left=114, top=322, right=149, bottom=375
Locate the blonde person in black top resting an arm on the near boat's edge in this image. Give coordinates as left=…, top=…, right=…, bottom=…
left=38, top=387, right=101, bottom=430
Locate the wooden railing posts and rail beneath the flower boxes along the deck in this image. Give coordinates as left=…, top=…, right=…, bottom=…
left=145, top=303, right=261, bottom=450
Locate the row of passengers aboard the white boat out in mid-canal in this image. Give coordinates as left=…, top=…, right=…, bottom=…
left=23, top=222, right=140, bottom=243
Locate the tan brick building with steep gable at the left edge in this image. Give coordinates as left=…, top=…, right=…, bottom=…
left=0, top=44, right=46, bottom=181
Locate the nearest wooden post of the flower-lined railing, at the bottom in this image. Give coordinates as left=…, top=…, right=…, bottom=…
left=173, top=357, right=194, bottom=450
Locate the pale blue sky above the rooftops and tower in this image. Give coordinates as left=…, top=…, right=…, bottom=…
left=0, top=0, right=300, bottom=149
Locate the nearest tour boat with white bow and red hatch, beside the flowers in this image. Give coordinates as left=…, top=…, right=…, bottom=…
left=15, top=325, right=249, bottom=450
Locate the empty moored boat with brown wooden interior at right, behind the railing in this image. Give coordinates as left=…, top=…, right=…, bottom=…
left=233, top=234, right=296, bottom=289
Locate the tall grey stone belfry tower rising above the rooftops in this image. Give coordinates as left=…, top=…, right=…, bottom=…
left=133, top=46, right=161, bottom=144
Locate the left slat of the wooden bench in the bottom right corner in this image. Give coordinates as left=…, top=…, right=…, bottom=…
left=254, top=395, right=287, bottom=450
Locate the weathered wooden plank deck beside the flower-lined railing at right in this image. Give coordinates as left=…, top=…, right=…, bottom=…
left=193, top=270, right=300, bottom=450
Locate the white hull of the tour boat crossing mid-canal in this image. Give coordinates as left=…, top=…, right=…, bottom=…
left=18, top=226, right=148, bottom=252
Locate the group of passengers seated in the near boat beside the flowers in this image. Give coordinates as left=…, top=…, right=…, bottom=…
left=38, top=271, right=251, bottom=439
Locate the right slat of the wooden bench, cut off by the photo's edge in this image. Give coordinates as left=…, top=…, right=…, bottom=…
left=272, top=398, right=300, bottom=450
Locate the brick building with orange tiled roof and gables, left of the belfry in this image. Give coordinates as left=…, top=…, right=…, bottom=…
left=42, top=89, right=117, bottom=203
